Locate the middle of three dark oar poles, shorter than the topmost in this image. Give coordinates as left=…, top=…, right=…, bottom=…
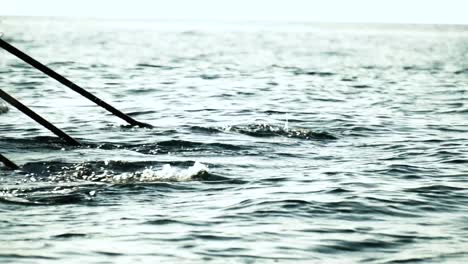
left=0, top=89, right=80, bottom=146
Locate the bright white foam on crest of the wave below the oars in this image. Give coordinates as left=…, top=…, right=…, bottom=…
left=112, top=161, right=208, bottom=183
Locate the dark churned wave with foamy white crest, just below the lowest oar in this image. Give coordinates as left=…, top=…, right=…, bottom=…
left=0, top=161, right=241, bottom=205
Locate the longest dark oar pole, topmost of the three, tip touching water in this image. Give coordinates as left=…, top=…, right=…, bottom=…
left=0, top=38, right=153, bottom=128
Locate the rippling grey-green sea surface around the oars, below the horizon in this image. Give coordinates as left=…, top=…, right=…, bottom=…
left=0, top=18, right=468, bottom=263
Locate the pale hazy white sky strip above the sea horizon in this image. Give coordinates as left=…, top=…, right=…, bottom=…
left=0, top=0, right=468, bottom=24
